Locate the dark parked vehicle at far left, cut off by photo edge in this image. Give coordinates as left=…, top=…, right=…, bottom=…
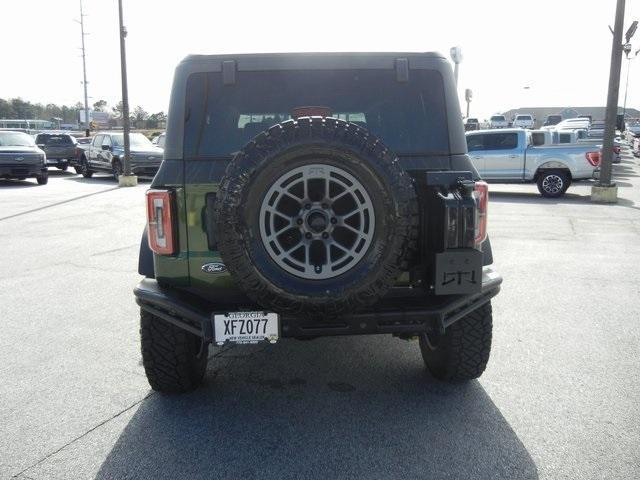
left=0, top=130, right=49, bottom=185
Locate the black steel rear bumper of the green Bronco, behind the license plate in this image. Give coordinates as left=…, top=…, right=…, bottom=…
left=134, top=267, right=502, bottom=342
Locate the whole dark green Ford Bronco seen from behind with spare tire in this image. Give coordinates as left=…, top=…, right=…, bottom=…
left=135, top=53, right=502, bottom=393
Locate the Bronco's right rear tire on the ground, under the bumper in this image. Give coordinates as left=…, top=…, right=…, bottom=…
left=420, top=302, right=492, bottom=382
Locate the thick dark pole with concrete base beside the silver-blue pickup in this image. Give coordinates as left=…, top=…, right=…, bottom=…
left=591, top=0, right=625, bottom=203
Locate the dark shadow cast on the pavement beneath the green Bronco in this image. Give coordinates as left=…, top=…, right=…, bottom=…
left=97, top=336, right=538, bottom=479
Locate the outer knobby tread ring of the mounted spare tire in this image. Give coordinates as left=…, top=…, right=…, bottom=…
left=214, top=117, right=419, bottom=316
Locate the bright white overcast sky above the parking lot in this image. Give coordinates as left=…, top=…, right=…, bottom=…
left=0, top=0, right=640, bottom=118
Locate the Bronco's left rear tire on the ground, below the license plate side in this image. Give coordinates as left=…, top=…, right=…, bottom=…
left=140, top=310, right=208, bottom=393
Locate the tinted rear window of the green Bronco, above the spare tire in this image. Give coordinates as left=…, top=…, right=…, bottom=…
left=184, top=70, right=449, bottom=158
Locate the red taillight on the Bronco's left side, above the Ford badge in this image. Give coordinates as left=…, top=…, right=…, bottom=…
left=147, top=190, right=176, bottom=255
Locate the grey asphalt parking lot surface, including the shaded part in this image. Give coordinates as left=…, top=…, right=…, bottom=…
left=0, top=154, right=640, bottom=479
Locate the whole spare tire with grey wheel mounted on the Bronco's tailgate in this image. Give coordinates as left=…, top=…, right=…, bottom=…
left=215, top=117, right=418, bottom=315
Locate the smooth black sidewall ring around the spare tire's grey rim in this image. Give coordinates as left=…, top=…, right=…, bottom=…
left=242, top=143, right=397, bottom=296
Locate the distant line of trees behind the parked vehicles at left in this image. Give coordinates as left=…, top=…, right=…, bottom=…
left=0, top=98, right=167, bottom=128
